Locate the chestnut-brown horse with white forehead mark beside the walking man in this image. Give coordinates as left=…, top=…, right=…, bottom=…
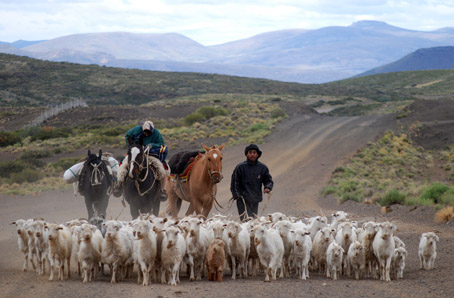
left=167, top=144, right=224, bottom=218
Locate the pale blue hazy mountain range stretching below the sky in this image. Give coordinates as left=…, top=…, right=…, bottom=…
left=0, top=21, right=454, bottom=83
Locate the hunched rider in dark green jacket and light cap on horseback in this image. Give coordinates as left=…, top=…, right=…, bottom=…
left=114, top=121, right=168, bottom=201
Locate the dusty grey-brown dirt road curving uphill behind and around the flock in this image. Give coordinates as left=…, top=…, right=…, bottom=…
left=0, top=115, right=454, bottom=297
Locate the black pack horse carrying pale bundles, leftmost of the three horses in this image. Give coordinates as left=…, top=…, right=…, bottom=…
left=79, top=150, right=113, bottom=219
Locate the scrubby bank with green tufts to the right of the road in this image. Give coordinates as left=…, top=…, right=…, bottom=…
left=322, top=131, right=454, bottom=207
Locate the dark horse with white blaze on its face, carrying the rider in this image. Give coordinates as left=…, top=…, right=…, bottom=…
left=123, top=143, right=165, bottom=219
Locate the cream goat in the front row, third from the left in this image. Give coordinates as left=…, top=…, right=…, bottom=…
left=44, top=223, right=72, bottom=280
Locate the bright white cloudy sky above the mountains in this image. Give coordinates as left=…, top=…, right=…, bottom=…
left=0, top=0, right=454, bottom=45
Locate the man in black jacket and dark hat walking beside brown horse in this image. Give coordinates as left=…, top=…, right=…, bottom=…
left=230, top=144, right=274, bottom=220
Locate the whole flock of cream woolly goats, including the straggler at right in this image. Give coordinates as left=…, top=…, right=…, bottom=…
left=12, top=211, right=439, bottom=286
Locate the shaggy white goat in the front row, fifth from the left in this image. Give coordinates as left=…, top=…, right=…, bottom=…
left=101, top=220, right=133, bottom=283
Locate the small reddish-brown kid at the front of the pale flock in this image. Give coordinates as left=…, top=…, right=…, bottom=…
left=205, top=238, right=225, bottom=282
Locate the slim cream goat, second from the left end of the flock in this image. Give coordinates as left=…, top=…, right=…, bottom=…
left=30, top=220, right=49, bottom=275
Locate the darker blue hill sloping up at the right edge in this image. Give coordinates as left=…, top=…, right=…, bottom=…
left=357, top=46, right=454, bottom=77
